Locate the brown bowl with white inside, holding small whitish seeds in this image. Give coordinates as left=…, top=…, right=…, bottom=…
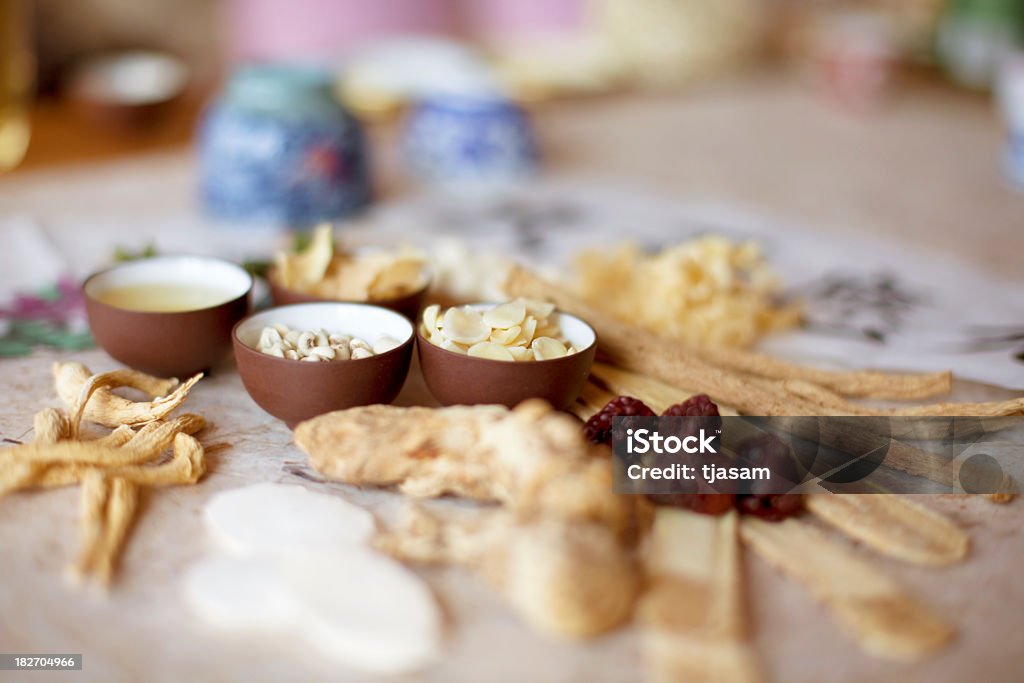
left=232, top=302, right=413, bottom=427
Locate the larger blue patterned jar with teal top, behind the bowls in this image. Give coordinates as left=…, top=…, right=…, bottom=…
left=199, top=66, right=371, bottom=227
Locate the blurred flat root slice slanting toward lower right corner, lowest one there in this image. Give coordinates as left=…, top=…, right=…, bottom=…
left=740, top=517, right=953, bottom=660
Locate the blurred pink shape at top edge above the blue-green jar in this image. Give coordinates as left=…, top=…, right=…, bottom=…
left=224, top=0, right=456, bottom=61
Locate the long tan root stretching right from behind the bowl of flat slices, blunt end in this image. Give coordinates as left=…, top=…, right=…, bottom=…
left=505, top=267, right=951, bottom=403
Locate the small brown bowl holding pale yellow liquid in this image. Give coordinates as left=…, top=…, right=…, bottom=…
left=82, top=256, right=253, bottom=377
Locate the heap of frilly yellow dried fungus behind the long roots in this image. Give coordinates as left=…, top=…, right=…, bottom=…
left=572, top=236, right=800, bottom=347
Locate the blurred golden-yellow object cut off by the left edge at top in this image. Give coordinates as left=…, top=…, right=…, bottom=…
left=0, top=0, right=34, bottom=172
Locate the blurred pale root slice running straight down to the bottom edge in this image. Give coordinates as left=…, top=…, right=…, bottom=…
left=638, top=508, right=761, bottom=683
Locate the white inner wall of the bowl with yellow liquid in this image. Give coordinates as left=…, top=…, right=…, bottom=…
left=85, top=256, right=253, bottom=305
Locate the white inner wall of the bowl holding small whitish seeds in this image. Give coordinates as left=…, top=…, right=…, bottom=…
left=236, top=302, right=413, bottom=348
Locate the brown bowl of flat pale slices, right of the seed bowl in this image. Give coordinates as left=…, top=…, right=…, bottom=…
left=417, top=304, right=597, bottom=410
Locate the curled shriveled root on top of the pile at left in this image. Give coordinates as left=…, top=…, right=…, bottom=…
left=53, top=362, right=203, bottom=433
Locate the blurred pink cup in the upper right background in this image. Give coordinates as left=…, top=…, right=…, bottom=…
left=814, top=12, right=897, bottom=112
